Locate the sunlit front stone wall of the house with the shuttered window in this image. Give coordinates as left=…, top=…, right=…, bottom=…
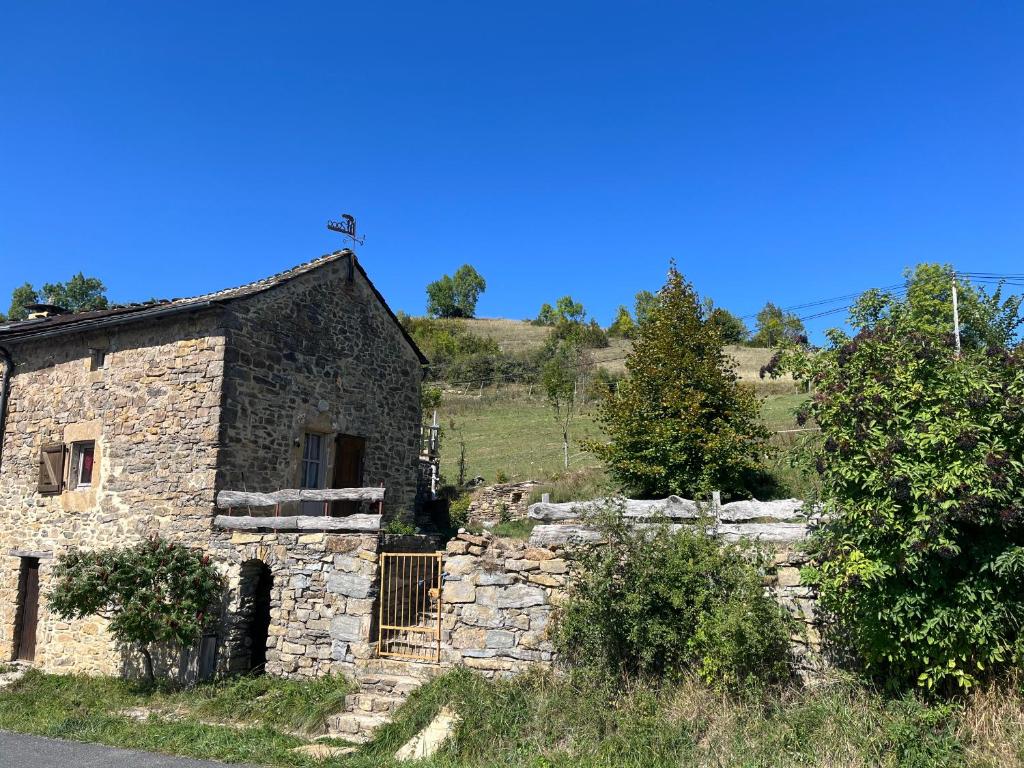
left=0, top=314, right=224, bottom=674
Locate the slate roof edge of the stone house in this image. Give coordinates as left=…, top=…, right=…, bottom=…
left=0, top=249, right=428, bottom=365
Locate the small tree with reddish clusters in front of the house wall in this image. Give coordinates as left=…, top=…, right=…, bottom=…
left=49, top=537, right=224, bottom=682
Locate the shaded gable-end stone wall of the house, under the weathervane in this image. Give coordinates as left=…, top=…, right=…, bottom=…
left=217, top=259, right=421, bottom=521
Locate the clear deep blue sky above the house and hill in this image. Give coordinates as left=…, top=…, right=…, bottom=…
left=0, top=0, right=1024, bottom=335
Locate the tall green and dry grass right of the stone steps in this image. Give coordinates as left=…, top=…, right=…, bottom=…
left=365, top=671, right=1024, bottom=768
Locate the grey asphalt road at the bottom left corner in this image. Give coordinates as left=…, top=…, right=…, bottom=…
left=0, top=731, right=256, bottom=768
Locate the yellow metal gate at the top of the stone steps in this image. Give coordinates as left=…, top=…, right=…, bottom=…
left=377, top=552, right=443, bottom=662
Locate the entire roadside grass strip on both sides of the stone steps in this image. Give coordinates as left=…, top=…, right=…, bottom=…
left=0, top=670, right=1024, bottom=768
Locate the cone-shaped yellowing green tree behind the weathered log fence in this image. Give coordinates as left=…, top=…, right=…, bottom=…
left=591, top=265, right=768, bottom=498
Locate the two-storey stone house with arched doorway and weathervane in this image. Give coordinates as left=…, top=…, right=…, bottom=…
left=0, top=250, right=426, bottom=674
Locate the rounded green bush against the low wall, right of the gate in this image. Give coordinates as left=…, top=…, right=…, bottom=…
left=556, top=508, right=790, bottom=689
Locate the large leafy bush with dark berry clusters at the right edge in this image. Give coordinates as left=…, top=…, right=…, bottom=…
left=787, top=270, right=1024, bottom=689
